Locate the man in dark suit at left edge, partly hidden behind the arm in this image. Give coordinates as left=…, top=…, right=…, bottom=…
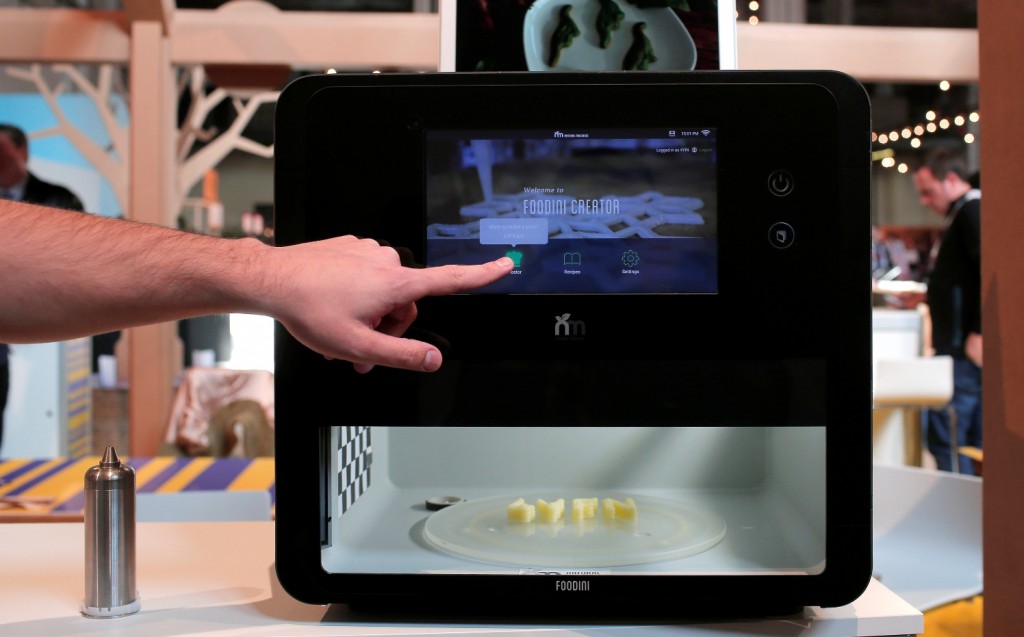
left=0, top=124, right=85, bottom=450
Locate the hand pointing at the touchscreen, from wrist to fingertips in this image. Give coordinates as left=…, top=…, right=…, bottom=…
left=263, top=237, right=512, bottom=373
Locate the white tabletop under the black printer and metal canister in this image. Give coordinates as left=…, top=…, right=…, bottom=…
left=0, top=522, right=924, bottom=637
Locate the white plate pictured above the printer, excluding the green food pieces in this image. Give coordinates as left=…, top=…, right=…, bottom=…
left=522, top=0, right=697, bottom=72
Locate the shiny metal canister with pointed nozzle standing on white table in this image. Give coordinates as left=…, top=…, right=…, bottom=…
left=82, top=447, right=141, bottom=618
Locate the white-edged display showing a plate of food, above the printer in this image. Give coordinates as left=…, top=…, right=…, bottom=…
left=438, top=0, right=736, bottom=72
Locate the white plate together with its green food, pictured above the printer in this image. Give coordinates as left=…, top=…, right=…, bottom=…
left=522, top=0, right=697, bottom=72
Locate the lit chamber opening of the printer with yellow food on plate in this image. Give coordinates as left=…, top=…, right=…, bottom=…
left=322, top=426, right=825, bottom=575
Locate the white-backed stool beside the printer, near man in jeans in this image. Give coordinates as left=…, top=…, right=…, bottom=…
left=874, top=356, right=959, bottom=471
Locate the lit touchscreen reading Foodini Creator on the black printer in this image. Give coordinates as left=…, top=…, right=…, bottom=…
left=425, top=127, right=718, bottom=294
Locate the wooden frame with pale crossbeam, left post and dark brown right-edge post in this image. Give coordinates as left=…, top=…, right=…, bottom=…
left=8, top=0, right=1024, bottom=632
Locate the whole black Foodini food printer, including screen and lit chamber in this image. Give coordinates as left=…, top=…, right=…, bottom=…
left=275, top=72, right=871, bottom=613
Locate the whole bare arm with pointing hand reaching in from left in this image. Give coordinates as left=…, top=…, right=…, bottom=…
left=0, top=201, right=512, bottom=372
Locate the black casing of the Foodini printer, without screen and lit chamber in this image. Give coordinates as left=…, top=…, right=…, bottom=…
left=274, top=72, right=871, bottom=614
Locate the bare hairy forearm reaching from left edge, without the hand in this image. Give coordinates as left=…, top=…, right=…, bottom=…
left=0, top=201, right=269, bottom=342
